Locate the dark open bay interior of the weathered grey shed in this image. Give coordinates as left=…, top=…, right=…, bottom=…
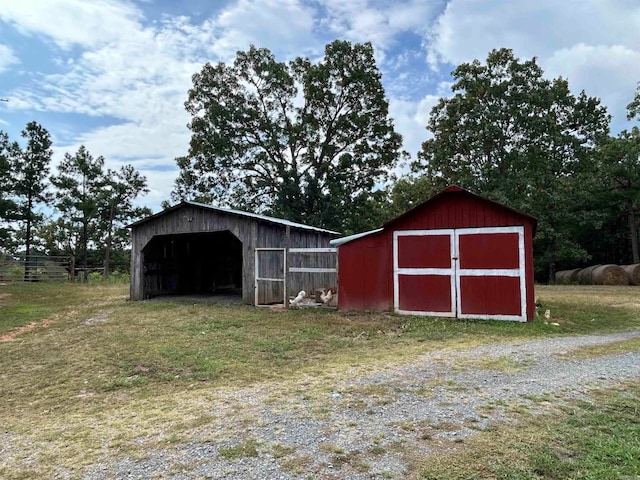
left=142, top=230, right=242, bottom=298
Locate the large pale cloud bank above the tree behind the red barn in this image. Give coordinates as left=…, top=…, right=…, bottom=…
left=425, top=0, right=640, bottom=130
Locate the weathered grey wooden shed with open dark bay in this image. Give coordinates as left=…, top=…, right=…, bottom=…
left=129, top=202, right=339, bottom=305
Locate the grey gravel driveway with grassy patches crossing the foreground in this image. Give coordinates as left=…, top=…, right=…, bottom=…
left=84, top=331, right=640, bottom=479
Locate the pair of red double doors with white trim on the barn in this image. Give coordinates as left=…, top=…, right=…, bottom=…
left=393, top=226, right=527, bottom=322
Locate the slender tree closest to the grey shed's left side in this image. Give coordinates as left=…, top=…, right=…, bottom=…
left=97, top=165, right=151, bottom=278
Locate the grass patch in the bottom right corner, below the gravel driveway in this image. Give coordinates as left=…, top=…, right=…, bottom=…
left=413, top=383, right=640, bottom=480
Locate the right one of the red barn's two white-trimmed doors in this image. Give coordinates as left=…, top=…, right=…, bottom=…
left=455, top=226, right=526, bottom=321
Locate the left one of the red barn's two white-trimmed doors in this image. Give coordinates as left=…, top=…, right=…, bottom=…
left=393, top=230, right=456, bottom=317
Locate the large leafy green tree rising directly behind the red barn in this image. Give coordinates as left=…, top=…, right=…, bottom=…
left=412, top=49, right=609, bottom=281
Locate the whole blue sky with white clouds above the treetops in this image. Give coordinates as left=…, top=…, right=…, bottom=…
left=0, top=0, right=640, bottom=211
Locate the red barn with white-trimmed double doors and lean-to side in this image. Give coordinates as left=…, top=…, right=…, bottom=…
left=331, top=186, right=536, bottom=322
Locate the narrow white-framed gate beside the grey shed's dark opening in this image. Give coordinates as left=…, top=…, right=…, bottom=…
left=254, top=248, right=287, bottom=305
